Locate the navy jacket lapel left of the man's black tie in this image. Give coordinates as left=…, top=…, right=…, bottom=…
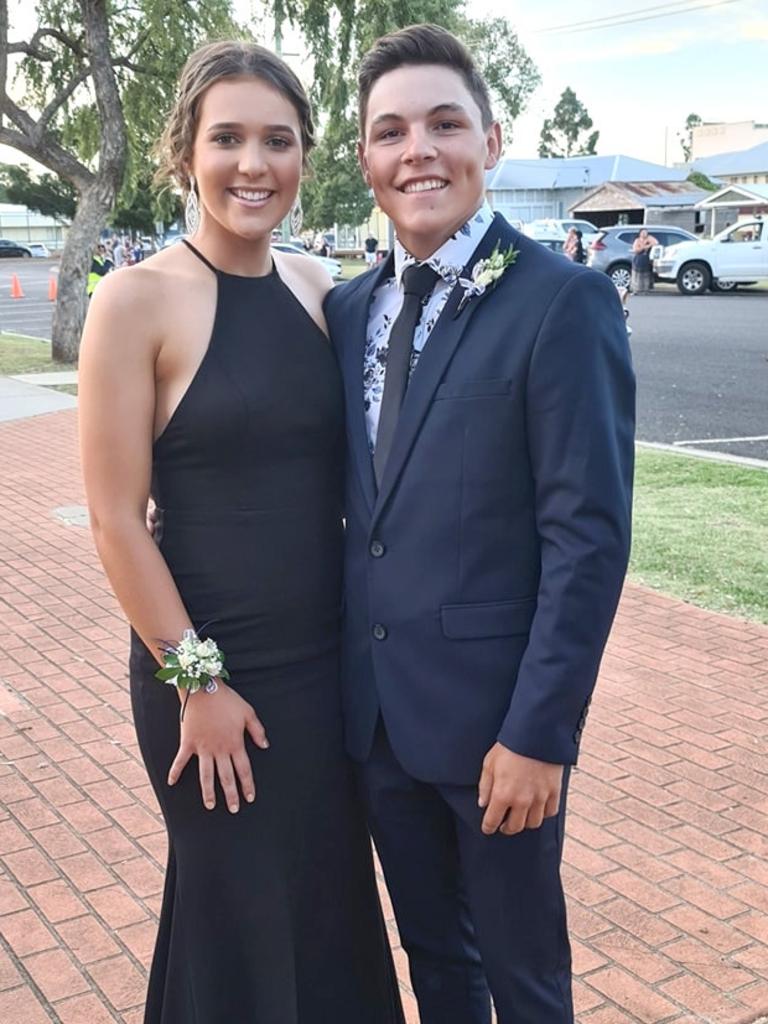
left=342, top=253, right=394, bottom=511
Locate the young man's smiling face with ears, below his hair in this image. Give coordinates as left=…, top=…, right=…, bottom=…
left=358, top=65, right=501, bottom=259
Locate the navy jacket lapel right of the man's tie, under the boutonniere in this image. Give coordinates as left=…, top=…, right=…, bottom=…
left=374, top=214, right=513, bottom=516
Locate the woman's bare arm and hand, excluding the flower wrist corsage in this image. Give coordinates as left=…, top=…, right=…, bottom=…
left=79, top=267, right=268, bottom=812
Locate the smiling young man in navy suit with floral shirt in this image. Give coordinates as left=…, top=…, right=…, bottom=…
left=326, top=26, right=635, bottom=1024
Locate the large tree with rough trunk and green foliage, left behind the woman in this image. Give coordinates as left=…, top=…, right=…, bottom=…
left=0, top=0, right=234, bottom=361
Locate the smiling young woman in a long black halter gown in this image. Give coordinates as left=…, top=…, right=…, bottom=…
left=80, top=42, right=402, bottom=1024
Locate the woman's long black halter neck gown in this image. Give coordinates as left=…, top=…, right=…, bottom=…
left=131, top=246, right=401, bottom=1024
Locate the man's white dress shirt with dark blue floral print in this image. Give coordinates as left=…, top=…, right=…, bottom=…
left=362, top=203, right=494, bottom=453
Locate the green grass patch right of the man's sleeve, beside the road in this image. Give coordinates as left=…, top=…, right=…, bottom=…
left=630, top=449, right=768, bottom=623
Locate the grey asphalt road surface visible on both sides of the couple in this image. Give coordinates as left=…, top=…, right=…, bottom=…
left=0, top=259, right=768, bottom=461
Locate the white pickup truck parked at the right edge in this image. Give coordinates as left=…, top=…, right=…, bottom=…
left=653, top=220, right=768, bottom=295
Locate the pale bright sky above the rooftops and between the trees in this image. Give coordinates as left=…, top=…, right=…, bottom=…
left=0, top=0, right=768, bottom=173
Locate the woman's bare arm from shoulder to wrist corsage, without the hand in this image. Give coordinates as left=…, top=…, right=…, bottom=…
left=78, top=267, right=191, bottom=662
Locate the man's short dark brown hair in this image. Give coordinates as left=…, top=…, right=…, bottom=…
left=357, top=25, right=494, bottom=138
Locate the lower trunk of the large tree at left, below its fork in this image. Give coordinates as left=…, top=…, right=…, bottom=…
left=51, top=181, right=115, bottom=362
